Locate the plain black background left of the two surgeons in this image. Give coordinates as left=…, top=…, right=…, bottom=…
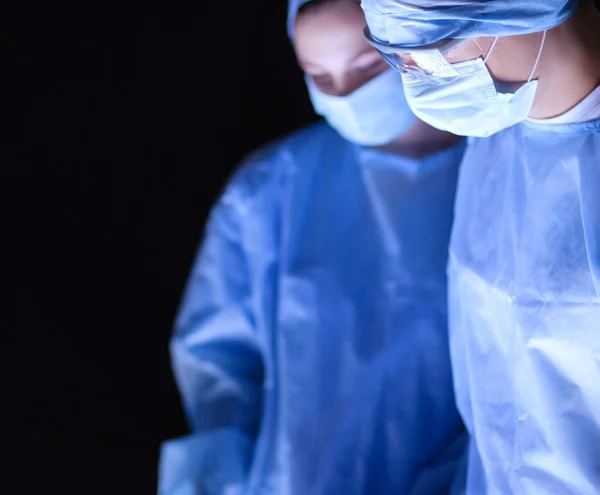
left=7, top=0, right=314, bottom=494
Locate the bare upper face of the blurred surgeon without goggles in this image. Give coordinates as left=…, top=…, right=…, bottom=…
left=293, top=1, right=388, bottom=96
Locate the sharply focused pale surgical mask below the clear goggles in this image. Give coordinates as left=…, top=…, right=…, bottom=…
left=402, top=31, right=546, bottom=137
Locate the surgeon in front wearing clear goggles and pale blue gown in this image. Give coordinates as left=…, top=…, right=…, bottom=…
left=362, top=0, right=600, bottom=495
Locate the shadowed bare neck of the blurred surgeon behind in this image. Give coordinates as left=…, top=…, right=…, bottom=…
left=376, top=120, right=461, bottom=160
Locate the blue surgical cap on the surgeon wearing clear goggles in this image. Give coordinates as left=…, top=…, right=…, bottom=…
left=361, top=0, right=579, bottom=47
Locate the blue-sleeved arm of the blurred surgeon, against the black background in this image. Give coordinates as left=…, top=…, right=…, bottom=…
left=159, top=187, right=263, bottom=494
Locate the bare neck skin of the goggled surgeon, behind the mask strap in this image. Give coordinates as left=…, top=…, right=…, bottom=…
left=529, top=0, right=600, bottom=119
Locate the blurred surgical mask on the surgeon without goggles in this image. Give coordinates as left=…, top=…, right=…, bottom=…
left=306, top=69, right=416, bottom=146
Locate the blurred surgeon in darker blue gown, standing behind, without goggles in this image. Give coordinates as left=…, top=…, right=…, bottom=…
left=159, top=0, right=467, bottom=495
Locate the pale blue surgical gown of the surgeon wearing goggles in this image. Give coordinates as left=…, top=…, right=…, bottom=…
left=449, top=118, right=600, bottom=495
